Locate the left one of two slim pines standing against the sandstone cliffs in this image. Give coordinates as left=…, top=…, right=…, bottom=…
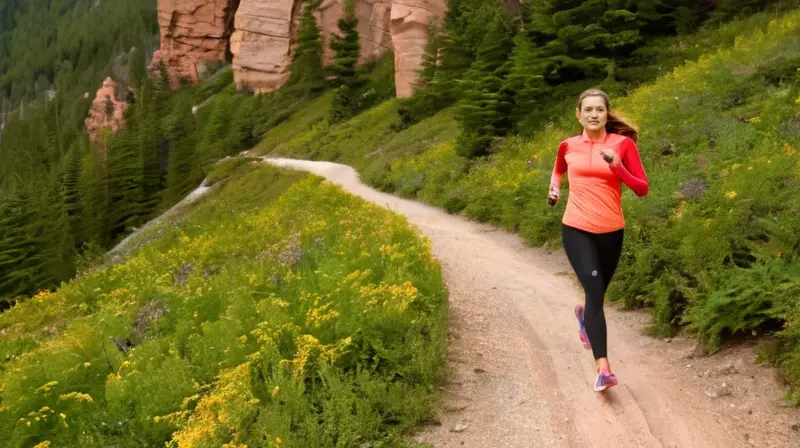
left=287, top=0, right=325, bottom=90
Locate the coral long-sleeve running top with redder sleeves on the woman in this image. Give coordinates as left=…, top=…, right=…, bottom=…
left=550, top=131, right=649, bottom=233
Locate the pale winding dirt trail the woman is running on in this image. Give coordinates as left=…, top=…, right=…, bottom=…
left=265, top=159, right=800, bottom=448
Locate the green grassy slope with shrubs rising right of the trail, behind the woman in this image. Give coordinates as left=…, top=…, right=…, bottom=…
left=257, top=10, right=800, bottom=400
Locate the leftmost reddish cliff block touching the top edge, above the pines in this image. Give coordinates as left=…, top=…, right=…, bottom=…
left=152, top=0, right=239, bottom=87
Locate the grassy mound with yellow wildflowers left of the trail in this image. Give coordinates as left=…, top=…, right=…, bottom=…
left=0, top=160, right=447, bottom=447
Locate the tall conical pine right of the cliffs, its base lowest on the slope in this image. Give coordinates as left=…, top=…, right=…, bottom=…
left=457, top=11, right=513, bottom=157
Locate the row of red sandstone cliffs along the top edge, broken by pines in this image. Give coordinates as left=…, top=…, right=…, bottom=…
left=154, top=0, right=447, bottom=97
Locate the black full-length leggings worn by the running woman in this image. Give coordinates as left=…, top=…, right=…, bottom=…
left=562, top=225, right=624, bottom=359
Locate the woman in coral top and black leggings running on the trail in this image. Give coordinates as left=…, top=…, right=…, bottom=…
left=548, top=89, right=649, bottom=392
